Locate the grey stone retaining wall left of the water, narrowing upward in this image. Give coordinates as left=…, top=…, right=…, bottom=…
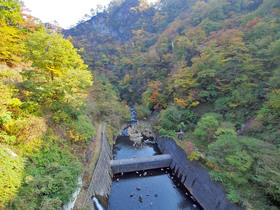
left=83, top=124, right=113, bottom=209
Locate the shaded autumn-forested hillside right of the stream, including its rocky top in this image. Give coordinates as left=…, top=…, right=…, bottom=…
left=64, top=0, right=280, bottom=209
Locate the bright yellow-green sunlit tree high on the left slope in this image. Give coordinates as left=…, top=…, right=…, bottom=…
left=22, top=28, right=92, bottom=103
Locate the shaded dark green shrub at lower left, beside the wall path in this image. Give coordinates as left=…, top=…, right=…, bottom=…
left=10, top=143, right=82, bottom=209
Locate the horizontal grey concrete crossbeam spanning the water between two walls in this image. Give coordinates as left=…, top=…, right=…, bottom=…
left=111, top=154, right=172, bottom=174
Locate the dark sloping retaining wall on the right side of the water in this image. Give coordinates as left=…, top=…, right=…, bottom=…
left=157, top=139, right=243, bottom=210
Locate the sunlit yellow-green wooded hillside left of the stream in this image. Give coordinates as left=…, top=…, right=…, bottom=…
left=0, top=0, right=129, bottom=209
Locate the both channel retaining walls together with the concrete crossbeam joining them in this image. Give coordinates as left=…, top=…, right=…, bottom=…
left=84, top=121, right=243, bottom=210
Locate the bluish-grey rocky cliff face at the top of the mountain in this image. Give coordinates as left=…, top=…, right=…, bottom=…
left=64, top=0, right=153, bottom=41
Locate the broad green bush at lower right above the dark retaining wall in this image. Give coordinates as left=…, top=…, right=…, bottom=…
left=207, top=135, right=280, bottom=203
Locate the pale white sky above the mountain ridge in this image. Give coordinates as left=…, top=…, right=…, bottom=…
left=22, top=0, right=159, bottom=29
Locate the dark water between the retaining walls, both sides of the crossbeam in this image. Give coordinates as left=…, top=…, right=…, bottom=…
left=108, top=136, right=200, bottom=210
